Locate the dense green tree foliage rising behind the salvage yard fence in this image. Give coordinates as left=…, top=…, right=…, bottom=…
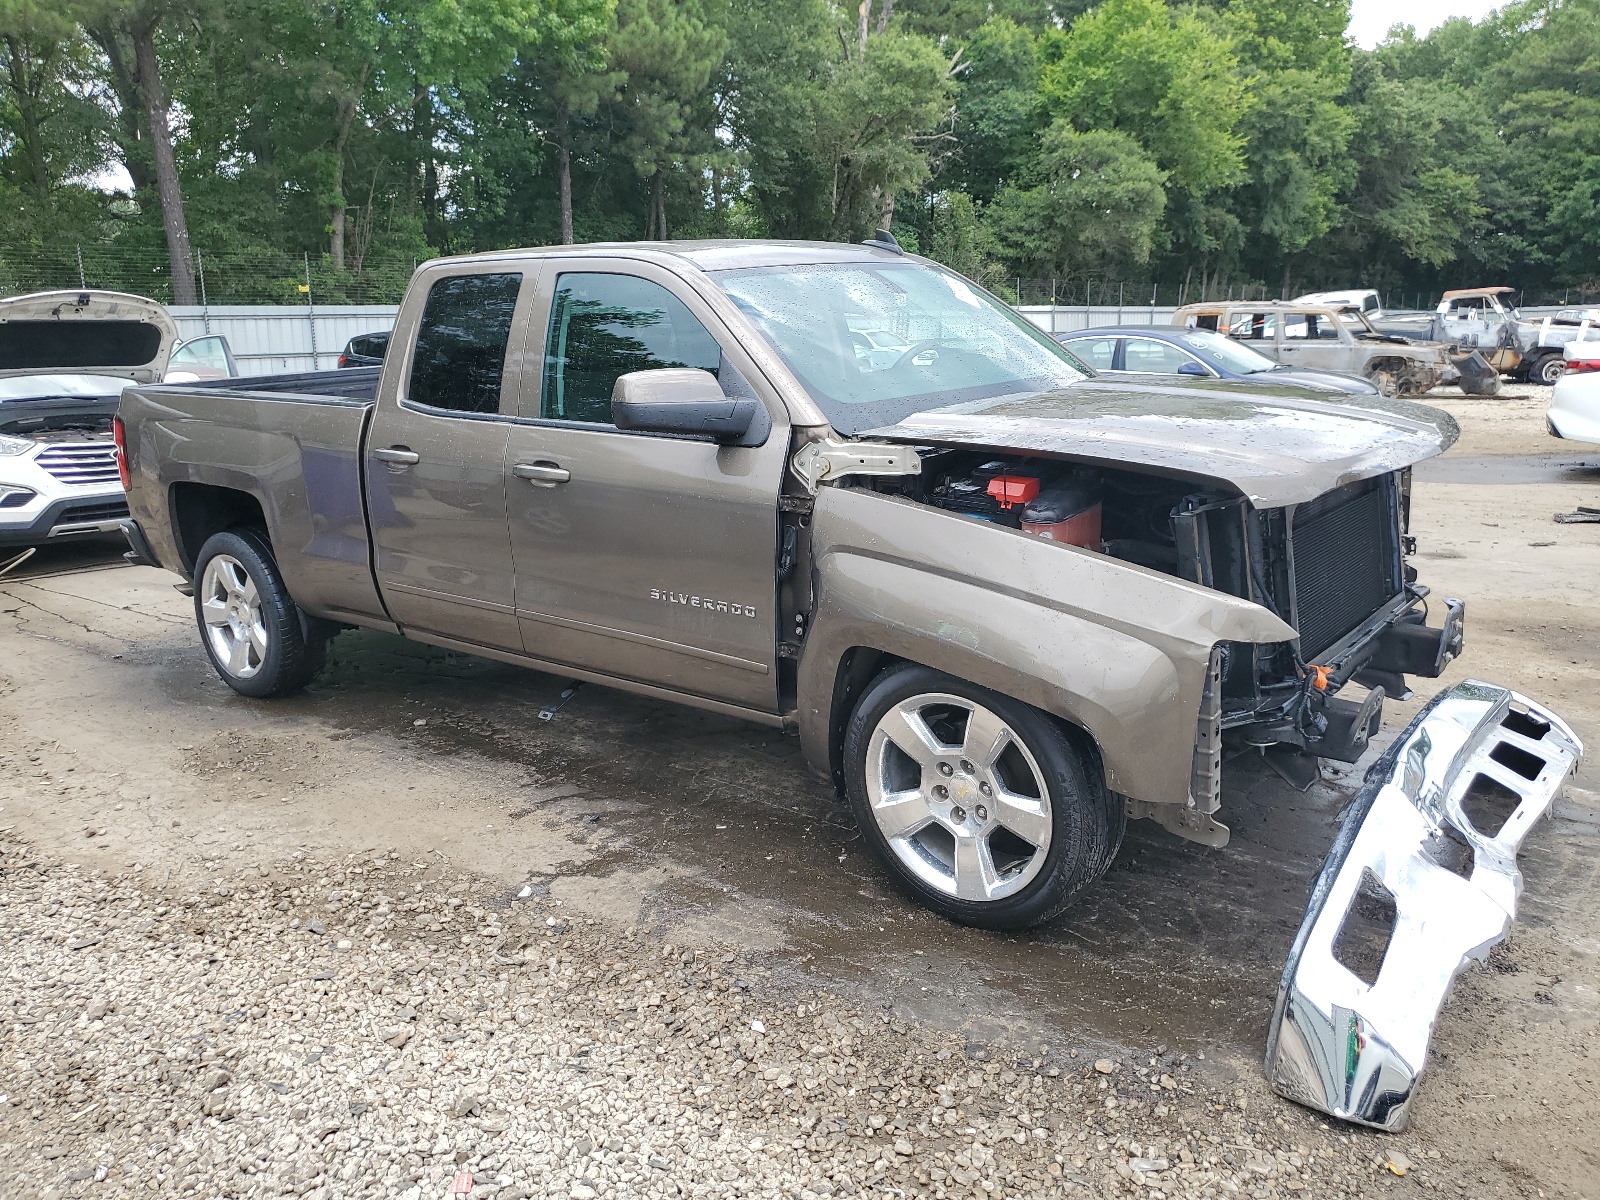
left=0, top=0, right=1600, bottom=302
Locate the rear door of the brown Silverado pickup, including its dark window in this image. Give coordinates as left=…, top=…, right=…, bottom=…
left=365, top=262, right=534, bottom=651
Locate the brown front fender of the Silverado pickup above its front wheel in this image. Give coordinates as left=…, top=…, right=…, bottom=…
left=797, top=488, right=1294, bottom=803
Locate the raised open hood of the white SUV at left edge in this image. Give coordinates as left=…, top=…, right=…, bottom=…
left=0, top=288, right=178, bottom=384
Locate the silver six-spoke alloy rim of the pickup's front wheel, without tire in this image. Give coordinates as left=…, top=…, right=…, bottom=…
left=866, top=693, right=1051, bottom=902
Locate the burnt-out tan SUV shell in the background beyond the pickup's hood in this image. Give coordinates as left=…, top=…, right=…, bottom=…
left=1173, top=301, right=1499, bottom=397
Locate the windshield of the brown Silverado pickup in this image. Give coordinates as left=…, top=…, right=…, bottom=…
left=717, top=262, right=1093, bottom=434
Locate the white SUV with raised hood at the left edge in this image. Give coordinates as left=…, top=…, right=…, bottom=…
left=0, top=291, right=178, bottom=549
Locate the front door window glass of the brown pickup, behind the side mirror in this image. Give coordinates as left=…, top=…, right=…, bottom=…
left=539, top=274, right=722, bottom=426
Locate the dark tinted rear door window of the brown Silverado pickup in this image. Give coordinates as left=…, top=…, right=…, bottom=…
left=410, top=274, right=522, bottom=413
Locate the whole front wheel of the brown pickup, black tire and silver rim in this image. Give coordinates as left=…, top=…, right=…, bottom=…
left=845, top=664, right=1126, bottom=930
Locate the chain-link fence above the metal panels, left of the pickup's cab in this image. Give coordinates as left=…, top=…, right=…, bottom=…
left=0, top=243, right=418, bottom=306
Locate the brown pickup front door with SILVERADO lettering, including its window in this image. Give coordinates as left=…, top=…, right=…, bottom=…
left=507, top=258, right=789, bottom=712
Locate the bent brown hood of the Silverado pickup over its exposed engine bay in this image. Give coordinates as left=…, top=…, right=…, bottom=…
left=861, top=379, right=1461, bottom=509
